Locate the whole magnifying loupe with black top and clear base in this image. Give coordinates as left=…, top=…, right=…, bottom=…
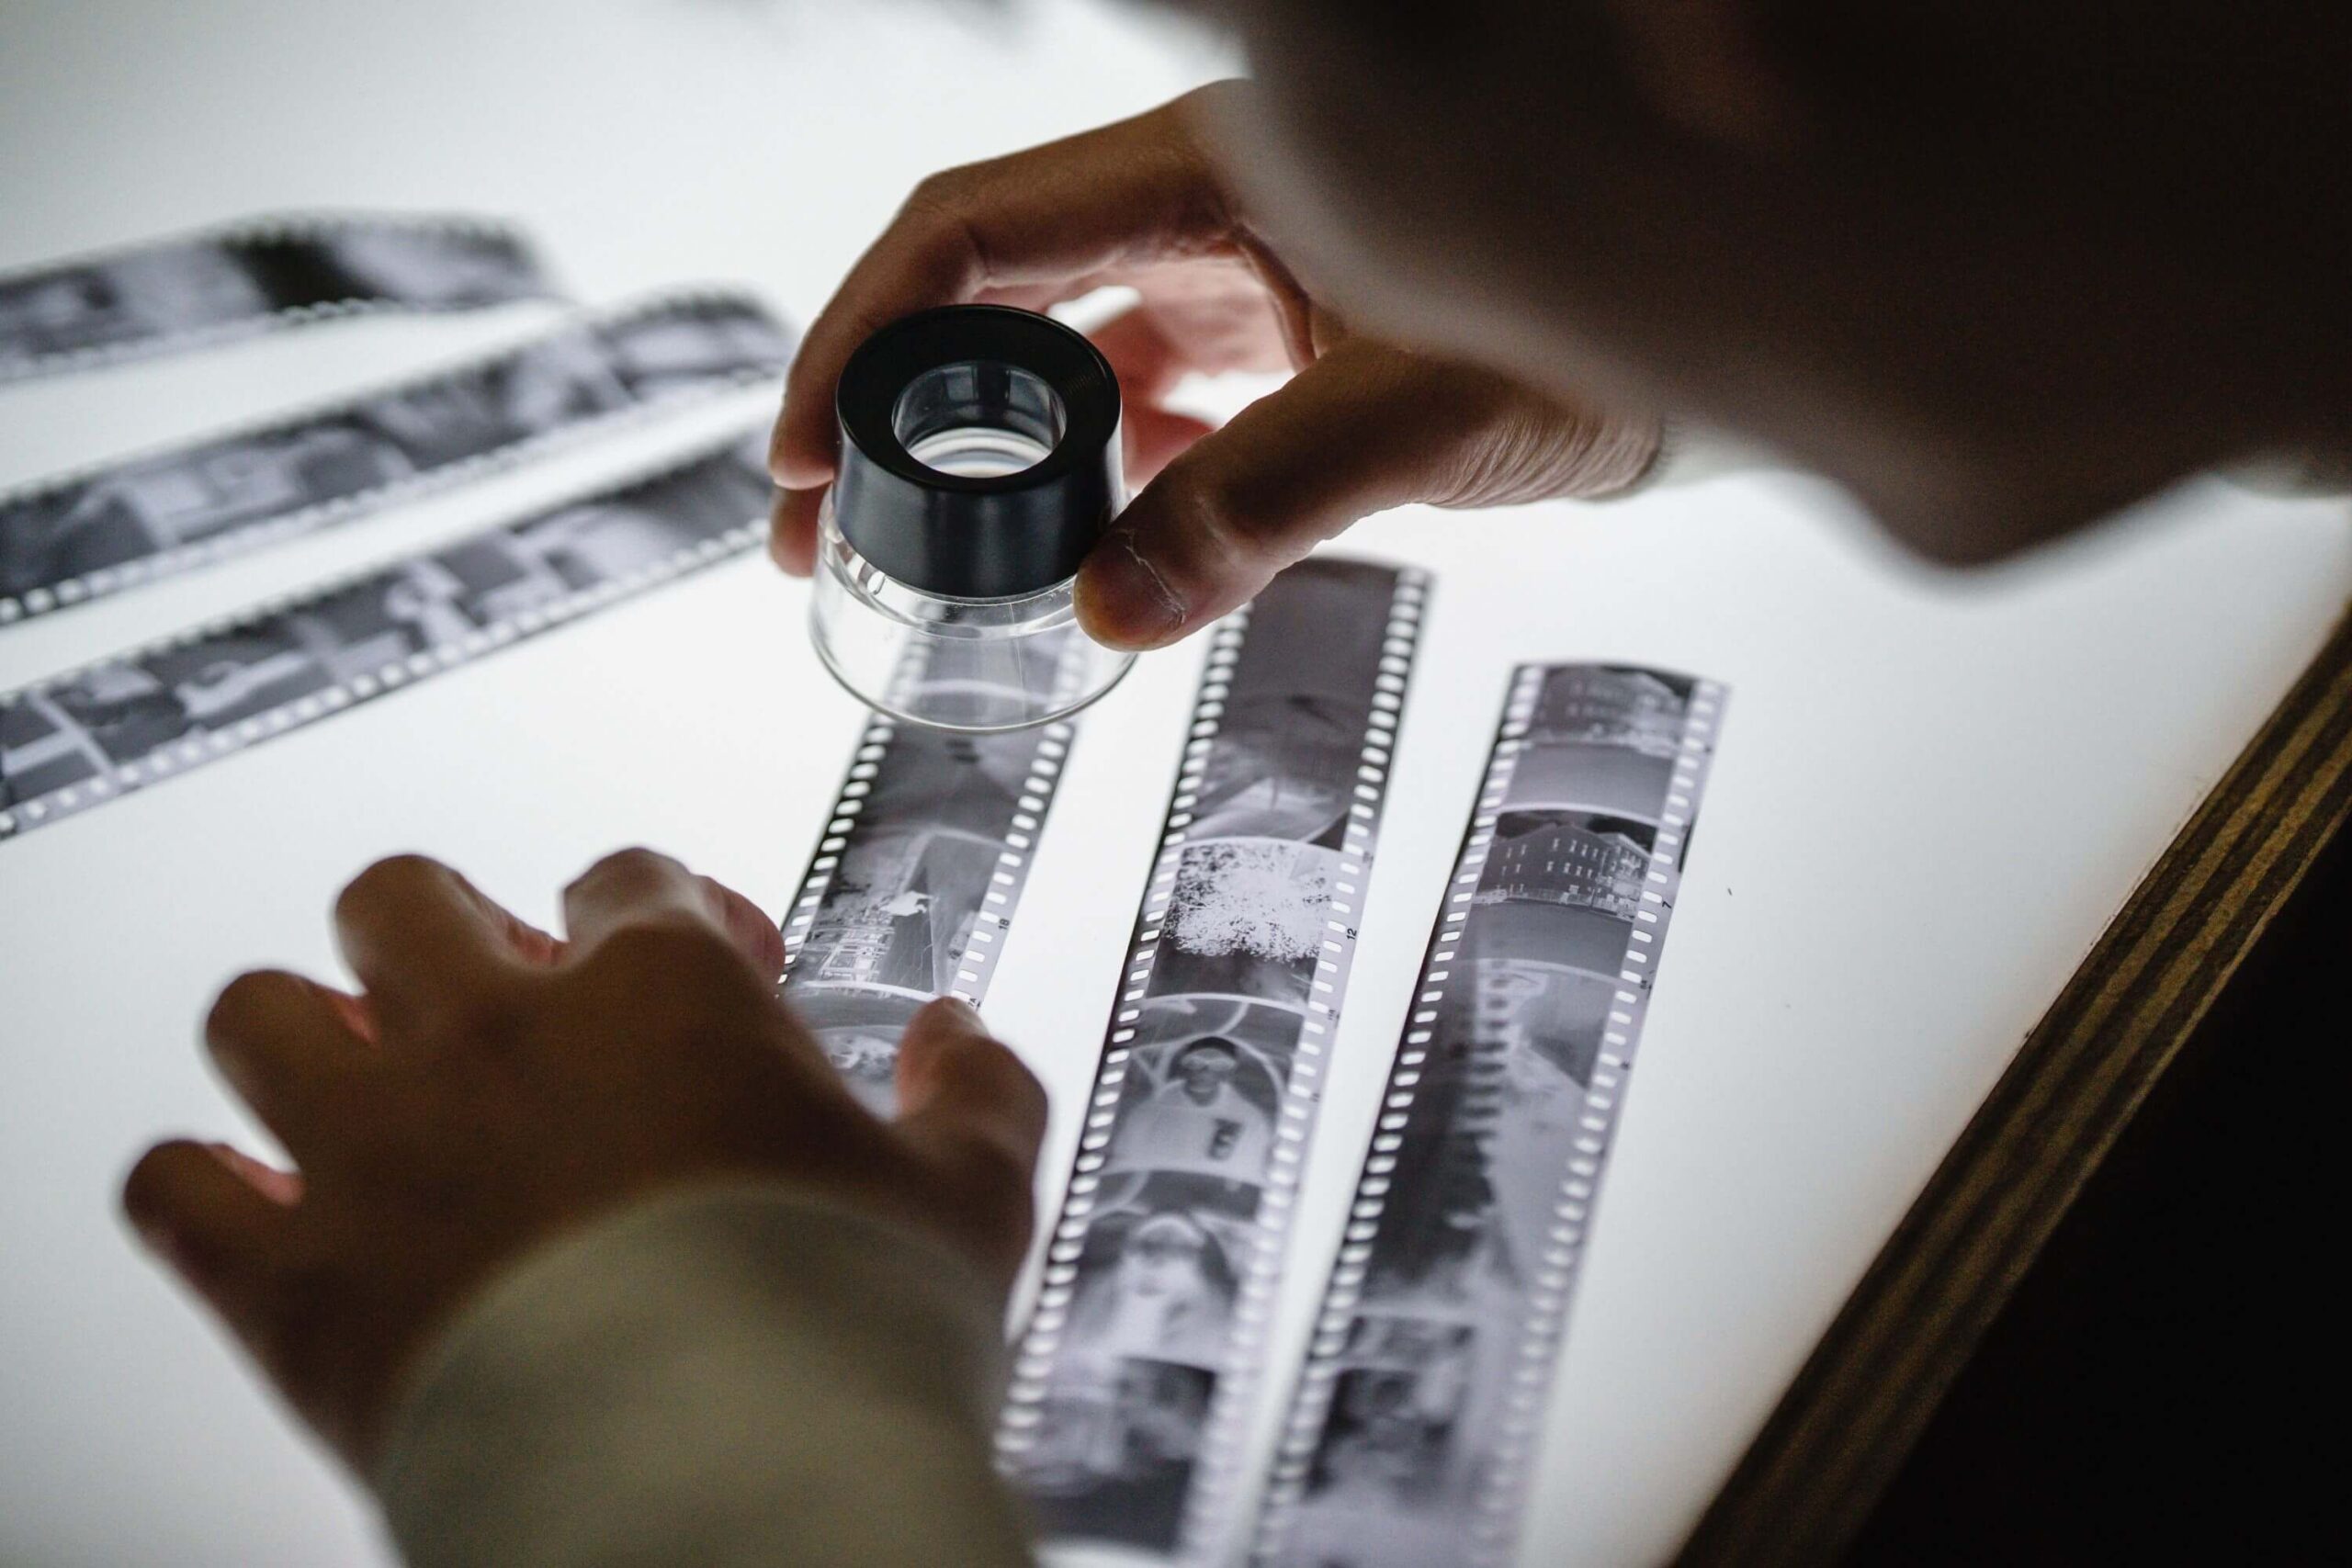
left=809, top=306, right=1134, bottom=731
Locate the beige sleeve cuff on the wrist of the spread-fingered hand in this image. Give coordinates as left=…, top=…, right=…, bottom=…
left=377, top=1187, right=1030, bottom=1568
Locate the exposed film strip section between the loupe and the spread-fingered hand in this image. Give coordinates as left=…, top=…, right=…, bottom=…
left=783, top=724, right=1068, bottom=1114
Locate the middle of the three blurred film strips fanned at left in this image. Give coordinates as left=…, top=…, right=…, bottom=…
left=0, top=291, right=793, bottom=626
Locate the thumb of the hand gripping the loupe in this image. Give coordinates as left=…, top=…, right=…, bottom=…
left=1077, top=339, right=1658, bottom=649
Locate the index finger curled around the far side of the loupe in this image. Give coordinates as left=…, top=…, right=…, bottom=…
left=769, top=83, right=1239, bottom=489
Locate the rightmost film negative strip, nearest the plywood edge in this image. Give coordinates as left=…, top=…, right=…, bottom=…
left=1253, top=665, right=1724, bottom=1568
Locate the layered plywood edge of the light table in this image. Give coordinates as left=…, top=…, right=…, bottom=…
left=1677, top=618, right=2352, bottom=1568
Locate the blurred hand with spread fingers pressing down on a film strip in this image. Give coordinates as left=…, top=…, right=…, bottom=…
left=122, top=849, right=1045, bottom=1474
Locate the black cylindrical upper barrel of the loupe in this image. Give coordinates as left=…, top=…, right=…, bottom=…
left=832, top=306, right=1125, bottom=600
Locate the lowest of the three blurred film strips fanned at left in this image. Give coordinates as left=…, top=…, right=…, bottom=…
left=0, top=434, right=774, bottom=840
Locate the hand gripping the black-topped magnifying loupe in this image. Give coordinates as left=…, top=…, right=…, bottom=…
left=769, top=83, right=1658, bottom=649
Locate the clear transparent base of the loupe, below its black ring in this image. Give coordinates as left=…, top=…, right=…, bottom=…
left=809, top=496, right=1136, bottom=733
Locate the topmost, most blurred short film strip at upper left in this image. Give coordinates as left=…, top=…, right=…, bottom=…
left=0, top=214, right=555, bottom=383
